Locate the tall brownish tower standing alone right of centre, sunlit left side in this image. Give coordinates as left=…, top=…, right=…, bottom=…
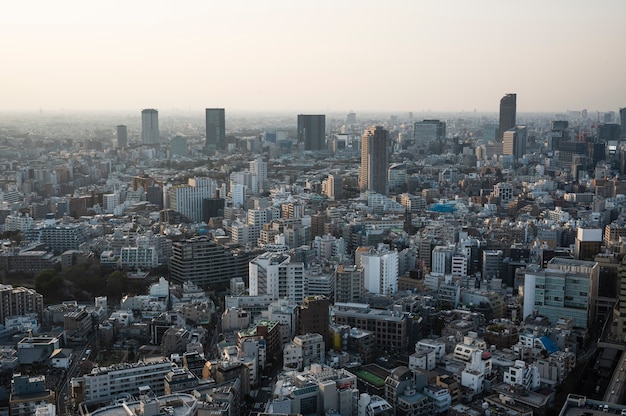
left=359, top=126, right=389, bottom=195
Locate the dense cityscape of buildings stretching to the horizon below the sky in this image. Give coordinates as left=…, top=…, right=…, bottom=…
left=0, top=98, right=626, bottom=416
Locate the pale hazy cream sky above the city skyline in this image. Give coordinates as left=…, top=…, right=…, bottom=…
left=0, top=0, right=626, bottom=113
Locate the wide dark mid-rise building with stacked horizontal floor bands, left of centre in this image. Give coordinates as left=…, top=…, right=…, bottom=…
left=170, top=236, right=249, bottom=286
